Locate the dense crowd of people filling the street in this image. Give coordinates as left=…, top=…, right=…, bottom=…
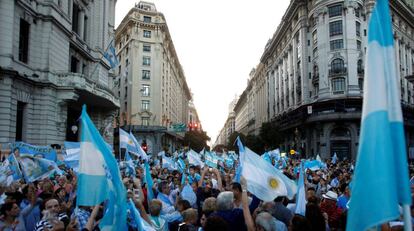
left=0, top=147, right=410, bottom=231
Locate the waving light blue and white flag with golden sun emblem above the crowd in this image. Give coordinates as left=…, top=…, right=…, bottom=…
left=241, top=147, right=287, bottom=202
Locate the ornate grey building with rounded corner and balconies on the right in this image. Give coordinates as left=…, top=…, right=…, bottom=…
left=236, top=0, right=414, bottom=158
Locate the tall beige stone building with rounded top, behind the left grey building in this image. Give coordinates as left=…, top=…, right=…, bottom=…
left=115, top=1, right=192, bottom=153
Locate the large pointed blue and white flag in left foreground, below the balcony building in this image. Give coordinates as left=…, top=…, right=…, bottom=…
left=76, top=106, right=127, bottom=230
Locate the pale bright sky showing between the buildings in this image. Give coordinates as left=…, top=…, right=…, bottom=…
left=115, top=0, right=290, bottom=144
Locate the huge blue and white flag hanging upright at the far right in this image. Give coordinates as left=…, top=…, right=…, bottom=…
left=347, top=0, right=411, bottom=231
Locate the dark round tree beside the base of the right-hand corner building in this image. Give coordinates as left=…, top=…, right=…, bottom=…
left=259, top=122, right=283, bottom=149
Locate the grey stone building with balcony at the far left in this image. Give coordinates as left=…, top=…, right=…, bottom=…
left=0, top=0, right=119, bottom=145
